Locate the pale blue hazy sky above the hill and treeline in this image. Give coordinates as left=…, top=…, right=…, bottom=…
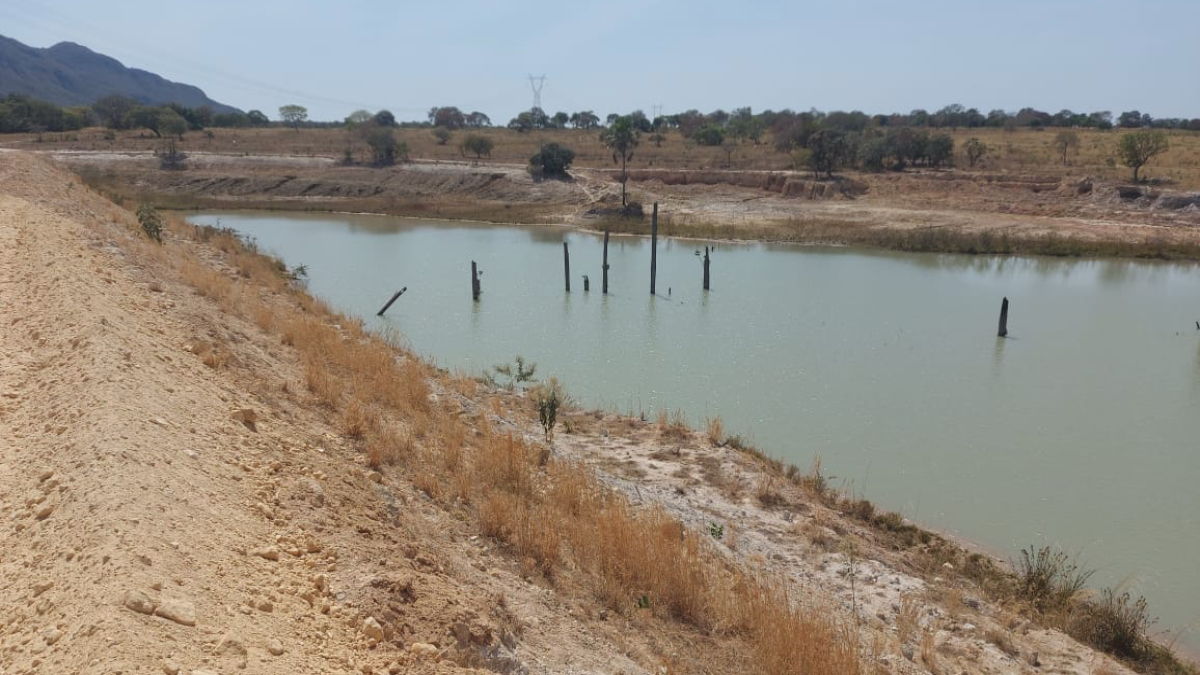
left=0, top=0, right=1200, bottom=124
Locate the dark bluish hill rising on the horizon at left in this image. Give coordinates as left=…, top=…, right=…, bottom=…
left=0, top=35, right=238, bottom=113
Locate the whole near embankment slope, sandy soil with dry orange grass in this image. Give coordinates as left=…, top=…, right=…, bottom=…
left=0, top=153, right=1190, bottom=675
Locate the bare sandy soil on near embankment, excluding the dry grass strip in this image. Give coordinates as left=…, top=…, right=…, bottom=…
left=0, top=153, right=1161, bottom=675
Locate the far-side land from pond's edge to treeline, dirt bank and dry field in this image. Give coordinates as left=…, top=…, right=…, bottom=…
left=7, top=123, right=1200, bottom=259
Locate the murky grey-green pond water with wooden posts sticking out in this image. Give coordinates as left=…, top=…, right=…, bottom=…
left=192, top=214, right=1200, bottom=649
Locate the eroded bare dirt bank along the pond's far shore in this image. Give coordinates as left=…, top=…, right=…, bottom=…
left=52, top=151, right=1200, bottom=257
